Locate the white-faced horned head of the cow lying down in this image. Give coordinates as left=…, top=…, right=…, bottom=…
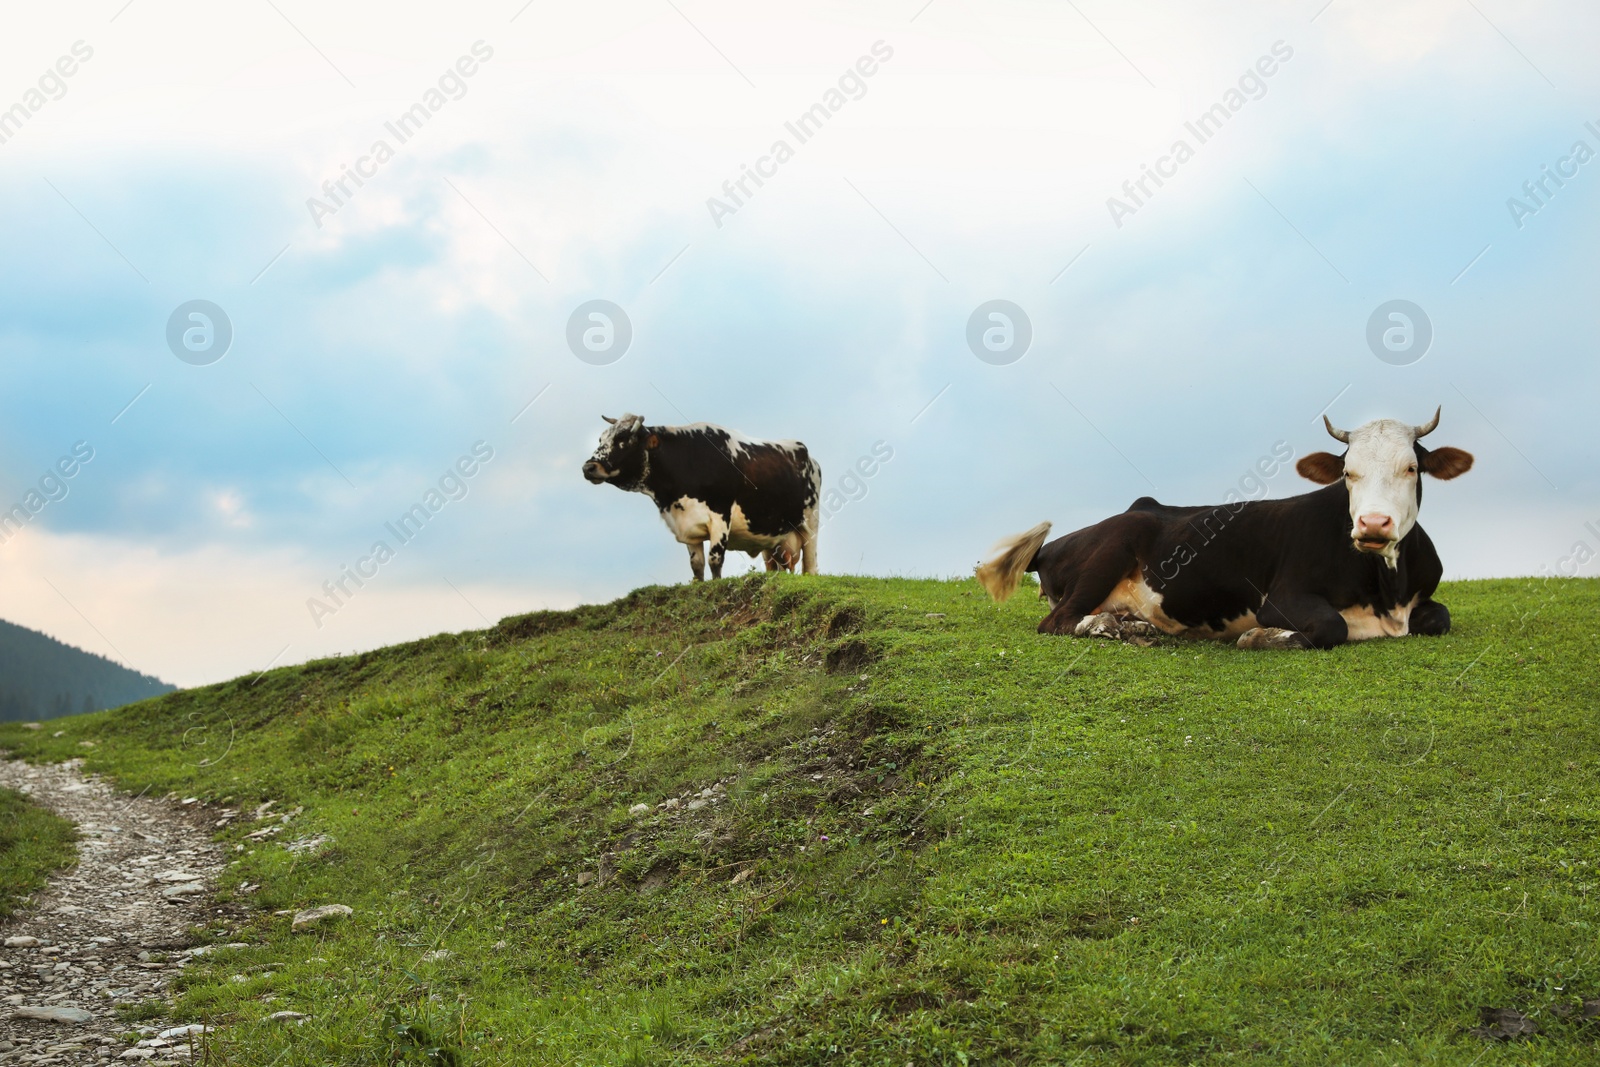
left=1294, top=404, right=1472, bottom=566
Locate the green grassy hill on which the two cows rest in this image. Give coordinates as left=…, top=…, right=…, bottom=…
left=0, top=576, right=1600, bottom=1067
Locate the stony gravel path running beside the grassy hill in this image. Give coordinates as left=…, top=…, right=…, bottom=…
left=0, top=760, right=226, bottom=1064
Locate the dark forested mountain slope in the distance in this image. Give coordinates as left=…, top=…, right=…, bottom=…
left=0, top=619, right=178, bottom=723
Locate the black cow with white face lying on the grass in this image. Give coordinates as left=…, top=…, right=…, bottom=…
left=978, top=411, right=1472, bottom=648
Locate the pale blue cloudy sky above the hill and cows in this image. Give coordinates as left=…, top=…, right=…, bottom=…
left=0, top=0, right=1600, bottom=686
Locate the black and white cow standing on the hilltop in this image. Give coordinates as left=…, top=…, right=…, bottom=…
left=584, top=414, right=822, bottom=582
